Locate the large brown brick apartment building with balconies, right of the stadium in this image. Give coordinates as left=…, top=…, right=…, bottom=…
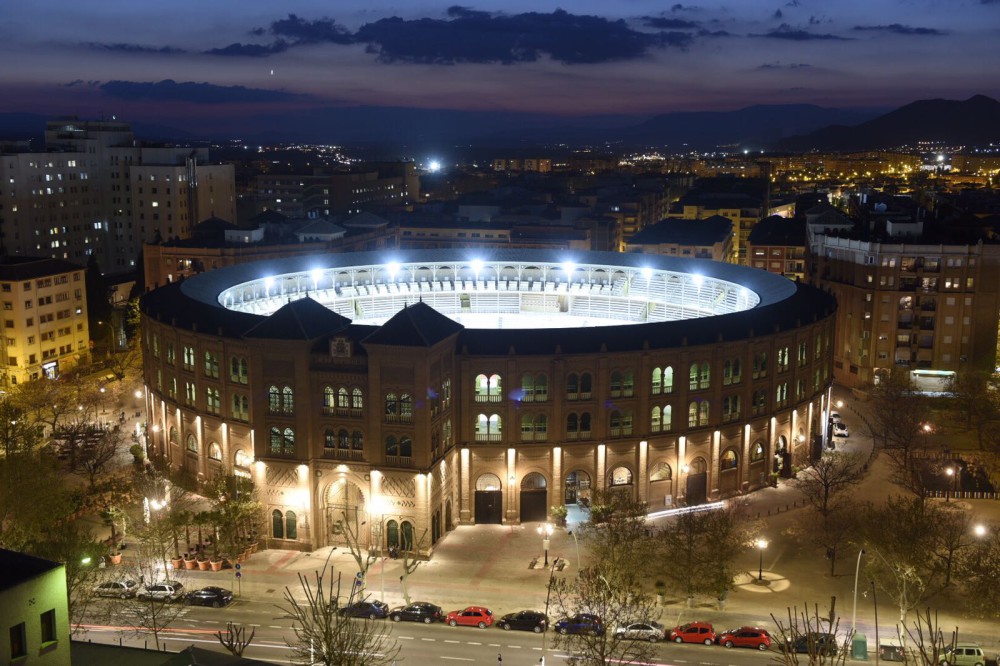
left=807, top=196, right=1000, bottom=387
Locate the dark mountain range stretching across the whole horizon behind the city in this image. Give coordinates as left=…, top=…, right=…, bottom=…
left=0, top=95, right=1000, bottom=153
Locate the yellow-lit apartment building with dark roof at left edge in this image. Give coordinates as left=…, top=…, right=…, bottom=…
left=0, top=257, right=90, bottom=387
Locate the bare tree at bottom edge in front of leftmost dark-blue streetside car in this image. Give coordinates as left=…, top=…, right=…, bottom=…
left=278, top=572, right=399, bottom=666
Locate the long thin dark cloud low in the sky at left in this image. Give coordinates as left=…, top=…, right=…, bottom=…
left=98, top=79, right=306, bottom=104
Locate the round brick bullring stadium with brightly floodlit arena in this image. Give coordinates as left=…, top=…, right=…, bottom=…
left=142, top=249, right=836, bottom=553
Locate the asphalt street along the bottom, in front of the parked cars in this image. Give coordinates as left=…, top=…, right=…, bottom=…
left=75, top=599, right=773, bottom=666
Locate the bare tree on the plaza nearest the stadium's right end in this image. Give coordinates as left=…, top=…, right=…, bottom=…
left=794, top=451, right=864, bottom=576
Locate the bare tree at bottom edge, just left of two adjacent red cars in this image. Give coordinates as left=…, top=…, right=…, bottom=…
left=550, top=563, right=659, bottom=666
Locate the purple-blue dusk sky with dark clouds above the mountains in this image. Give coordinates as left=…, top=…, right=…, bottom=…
left=0, top=0, right=1000, bottom=135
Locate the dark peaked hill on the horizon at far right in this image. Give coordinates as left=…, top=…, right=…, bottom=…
left=776, top=95, right=1000, bottom=151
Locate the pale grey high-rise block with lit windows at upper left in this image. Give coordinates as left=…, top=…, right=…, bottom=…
left=0, top=118, right=236, bottom=274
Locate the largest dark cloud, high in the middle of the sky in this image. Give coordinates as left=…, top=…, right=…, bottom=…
left=354, top=7, right=692, bottom=64
